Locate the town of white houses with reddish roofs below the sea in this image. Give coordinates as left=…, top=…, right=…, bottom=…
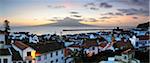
left=0, top=21, right=150, bottom=63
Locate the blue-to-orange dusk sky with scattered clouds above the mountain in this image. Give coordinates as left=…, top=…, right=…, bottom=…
left=0, top=0, right=149, bottom=26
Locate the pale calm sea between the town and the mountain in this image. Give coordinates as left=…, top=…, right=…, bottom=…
left=8, top=26, right=134, bottom=35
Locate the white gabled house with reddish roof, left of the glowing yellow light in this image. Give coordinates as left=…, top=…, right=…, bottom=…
left=12, top=41, right=36, bottom=63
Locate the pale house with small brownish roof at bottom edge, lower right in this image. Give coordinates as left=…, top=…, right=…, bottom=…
left=99, top=49, right=140, bottom=63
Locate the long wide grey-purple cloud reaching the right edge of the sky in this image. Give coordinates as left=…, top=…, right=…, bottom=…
left=118, top=8, right=149, bottom=16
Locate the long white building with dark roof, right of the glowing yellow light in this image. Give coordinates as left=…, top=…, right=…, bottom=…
left=28, top=42, right=65, bottom=63
